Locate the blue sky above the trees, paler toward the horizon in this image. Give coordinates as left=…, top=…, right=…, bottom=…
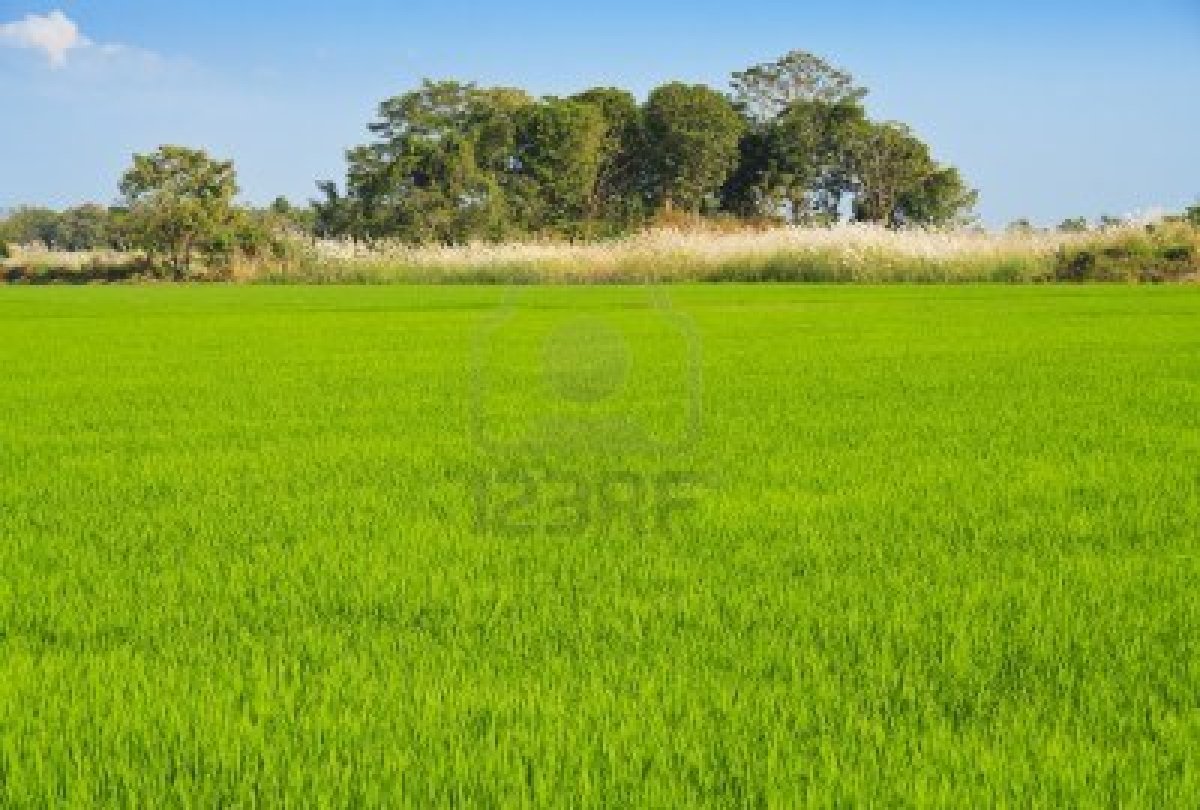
left=0, top=0, right=1200, bottom=224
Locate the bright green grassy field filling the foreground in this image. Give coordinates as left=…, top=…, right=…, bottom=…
left=0, top=286, right=1200, bottom=808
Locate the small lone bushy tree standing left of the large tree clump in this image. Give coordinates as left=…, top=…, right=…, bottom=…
left=121, top=146, right=238, bottom=278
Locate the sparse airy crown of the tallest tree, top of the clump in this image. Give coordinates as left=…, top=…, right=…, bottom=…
left=732, top=50, right=866, bottom=121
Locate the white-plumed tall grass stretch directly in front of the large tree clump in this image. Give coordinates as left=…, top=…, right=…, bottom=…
left=268, top=224, right=1099, bottom=283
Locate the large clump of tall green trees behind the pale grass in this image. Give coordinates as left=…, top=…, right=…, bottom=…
left=313, top=52, right=976, bottom=244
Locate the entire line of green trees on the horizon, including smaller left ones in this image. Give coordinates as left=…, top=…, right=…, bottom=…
left=0, top=52, right=1200, bottom=277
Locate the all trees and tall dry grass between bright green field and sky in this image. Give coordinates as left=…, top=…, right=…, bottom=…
left=0, top=52, right=1200, bottom=283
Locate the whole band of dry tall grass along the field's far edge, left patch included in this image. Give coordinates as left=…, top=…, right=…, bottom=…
left=7, top=222, right=1200, bottom=283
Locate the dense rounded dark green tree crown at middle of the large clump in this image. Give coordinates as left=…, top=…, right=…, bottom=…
left=644, top=83, right=744, bottom=212
